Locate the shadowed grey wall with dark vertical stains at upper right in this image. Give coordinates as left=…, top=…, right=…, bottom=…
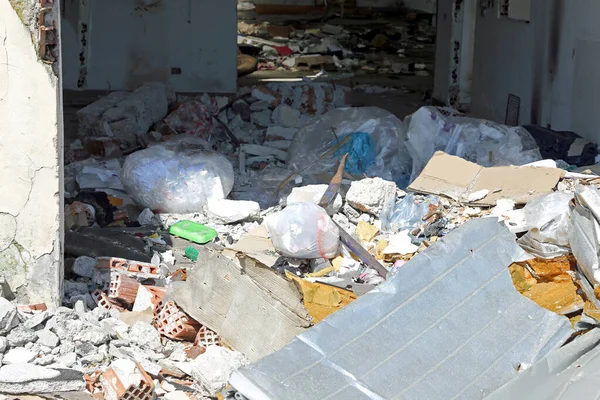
left=473, top=0, right=600, bottom=142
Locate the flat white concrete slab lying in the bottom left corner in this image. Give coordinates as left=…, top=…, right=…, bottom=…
left=0, top=363, right=85, bottom=394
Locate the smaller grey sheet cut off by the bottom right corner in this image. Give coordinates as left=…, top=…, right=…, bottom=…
left=486, top=329, right=600, bottom=400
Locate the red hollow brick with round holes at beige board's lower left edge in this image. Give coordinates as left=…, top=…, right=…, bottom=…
left=154, top=301, right=202, bottom=342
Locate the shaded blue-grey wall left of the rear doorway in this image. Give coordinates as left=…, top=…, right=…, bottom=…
left=62, top=0, right=237, bottom=93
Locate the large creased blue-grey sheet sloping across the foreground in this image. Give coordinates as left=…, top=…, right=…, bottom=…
left=230, top=218, right=572, bottom=400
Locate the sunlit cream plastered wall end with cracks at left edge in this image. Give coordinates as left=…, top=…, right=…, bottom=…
left=0, top=0, right=63, bottom=307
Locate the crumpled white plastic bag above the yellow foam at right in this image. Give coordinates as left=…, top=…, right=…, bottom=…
left=517, top=192, right=573, bottom=258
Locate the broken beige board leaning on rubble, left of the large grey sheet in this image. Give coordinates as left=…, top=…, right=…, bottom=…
left=173, top=247, right=312, bottom=361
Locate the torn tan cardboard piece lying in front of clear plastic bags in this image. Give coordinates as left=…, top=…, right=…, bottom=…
left=408, top=151, right=565, bottom=206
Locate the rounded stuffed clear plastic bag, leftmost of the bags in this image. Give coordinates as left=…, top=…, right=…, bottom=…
left=121, top=135, right=234, bottom=214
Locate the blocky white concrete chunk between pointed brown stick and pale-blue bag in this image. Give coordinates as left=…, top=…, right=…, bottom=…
left=346, top=178, right=396, bottom=216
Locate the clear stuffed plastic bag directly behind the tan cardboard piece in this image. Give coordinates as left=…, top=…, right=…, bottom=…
left=404, top=107, right=542, bottom=182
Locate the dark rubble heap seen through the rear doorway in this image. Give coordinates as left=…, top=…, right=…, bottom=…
left=238, top=14, right=435, bottom=76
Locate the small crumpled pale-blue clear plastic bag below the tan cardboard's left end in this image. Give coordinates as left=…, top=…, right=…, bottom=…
left=381, top=193, right=439, bottom=232
